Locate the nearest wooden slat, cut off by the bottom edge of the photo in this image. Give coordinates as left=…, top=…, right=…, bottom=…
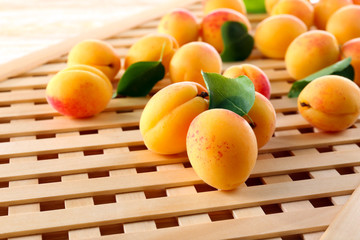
left=105, top=207, right=340, bottom=240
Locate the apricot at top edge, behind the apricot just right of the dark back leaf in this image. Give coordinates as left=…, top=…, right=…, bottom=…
left=271, top=0, right=314, bottom=28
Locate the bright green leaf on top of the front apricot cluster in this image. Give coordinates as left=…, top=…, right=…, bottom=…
left=201, top=72, right=255, bottom=116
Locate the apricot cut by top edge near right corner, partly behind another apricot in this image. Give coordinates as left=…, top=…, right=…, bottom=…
left=314, top=0, right=352, bottom=30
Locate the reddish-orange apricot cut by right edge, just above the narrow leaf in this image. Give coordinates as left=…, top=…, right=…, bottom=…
left=341, top=38, right=360, bottom=86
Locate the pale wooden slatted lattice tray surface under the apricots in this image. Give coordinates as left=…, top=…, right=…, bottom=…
left=0, top=1, right=360, bottom=240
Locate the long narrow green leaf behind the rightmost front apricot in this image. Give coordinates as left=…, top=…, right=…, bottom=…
left=288, top=57, right=354, bottom=98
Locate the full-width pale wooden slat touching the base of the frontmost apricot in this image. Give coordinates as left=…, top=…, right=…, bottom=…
left=0, top=174, right=360, bottom=237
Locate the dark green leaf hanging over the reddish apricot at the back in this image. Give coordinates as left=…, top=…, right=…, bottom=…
left=221, top=21, right=254, bottom=62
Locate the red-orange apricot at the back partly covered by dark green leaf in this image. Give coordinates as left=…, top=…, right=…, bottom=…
left=200, top=8, right=251, bottom=53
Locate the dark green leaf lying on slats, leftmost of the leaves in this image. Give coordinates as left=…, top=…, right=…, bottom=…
left=114, top=61, right=165, bottom=97
